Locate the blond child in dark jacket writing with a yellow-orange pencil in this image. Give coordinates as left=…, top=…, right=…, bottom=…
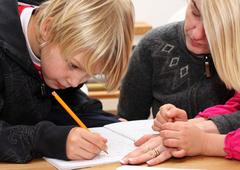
left=0, top=0, right=134, bottom=163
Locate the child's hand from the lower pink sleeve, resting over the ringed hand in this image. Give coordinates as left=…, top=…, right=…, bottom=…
left=160, top=122, right=207, bottom=158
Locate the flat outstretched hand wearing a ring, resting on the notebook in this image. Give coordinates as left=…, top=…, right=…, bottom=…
left=120, top=135, right=171, bottom=166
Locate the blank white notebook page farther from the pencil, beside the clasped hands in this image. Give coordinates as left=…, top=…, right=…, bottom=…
left=104, top=119, right=157, bottom=141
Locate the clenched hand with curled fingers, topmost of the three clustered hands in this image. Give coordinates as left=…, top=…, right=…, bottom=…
left=152, top=104, right=187, bottom=131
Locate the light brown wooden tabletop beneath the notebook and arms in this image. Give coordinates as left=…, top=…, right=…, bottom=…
left=0, top=156, right=240, bottom=170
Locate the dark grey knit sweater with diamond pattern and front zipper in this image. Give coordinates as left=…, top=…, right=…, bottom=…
left=118, top=22, right=234, bottom=120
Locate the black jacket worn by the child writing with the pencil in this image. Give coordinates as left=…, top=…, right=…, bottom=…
left=0, top=0, right=118, bottom=163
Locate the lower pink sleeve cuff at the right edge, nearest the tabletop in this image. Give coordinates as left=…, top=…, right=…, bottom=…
left=224, top=128, right=240, bottom=160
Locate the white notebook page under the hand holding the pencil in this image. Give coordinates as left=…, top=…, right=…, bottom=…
left=45, top=127, right=135, bottom=170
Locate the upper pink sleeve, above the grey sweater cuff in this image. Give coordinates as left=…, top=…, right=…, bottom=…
left=196, top=92, right=240, bottom=118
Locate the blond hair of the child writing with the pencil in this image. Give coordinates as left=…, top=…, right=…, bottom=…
left=37, top=0, right=134, bottom=90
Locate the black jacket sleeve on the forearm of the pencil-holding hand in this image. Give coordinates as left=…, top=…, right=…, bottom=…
left=0, top=121, right=71, bottom=163
